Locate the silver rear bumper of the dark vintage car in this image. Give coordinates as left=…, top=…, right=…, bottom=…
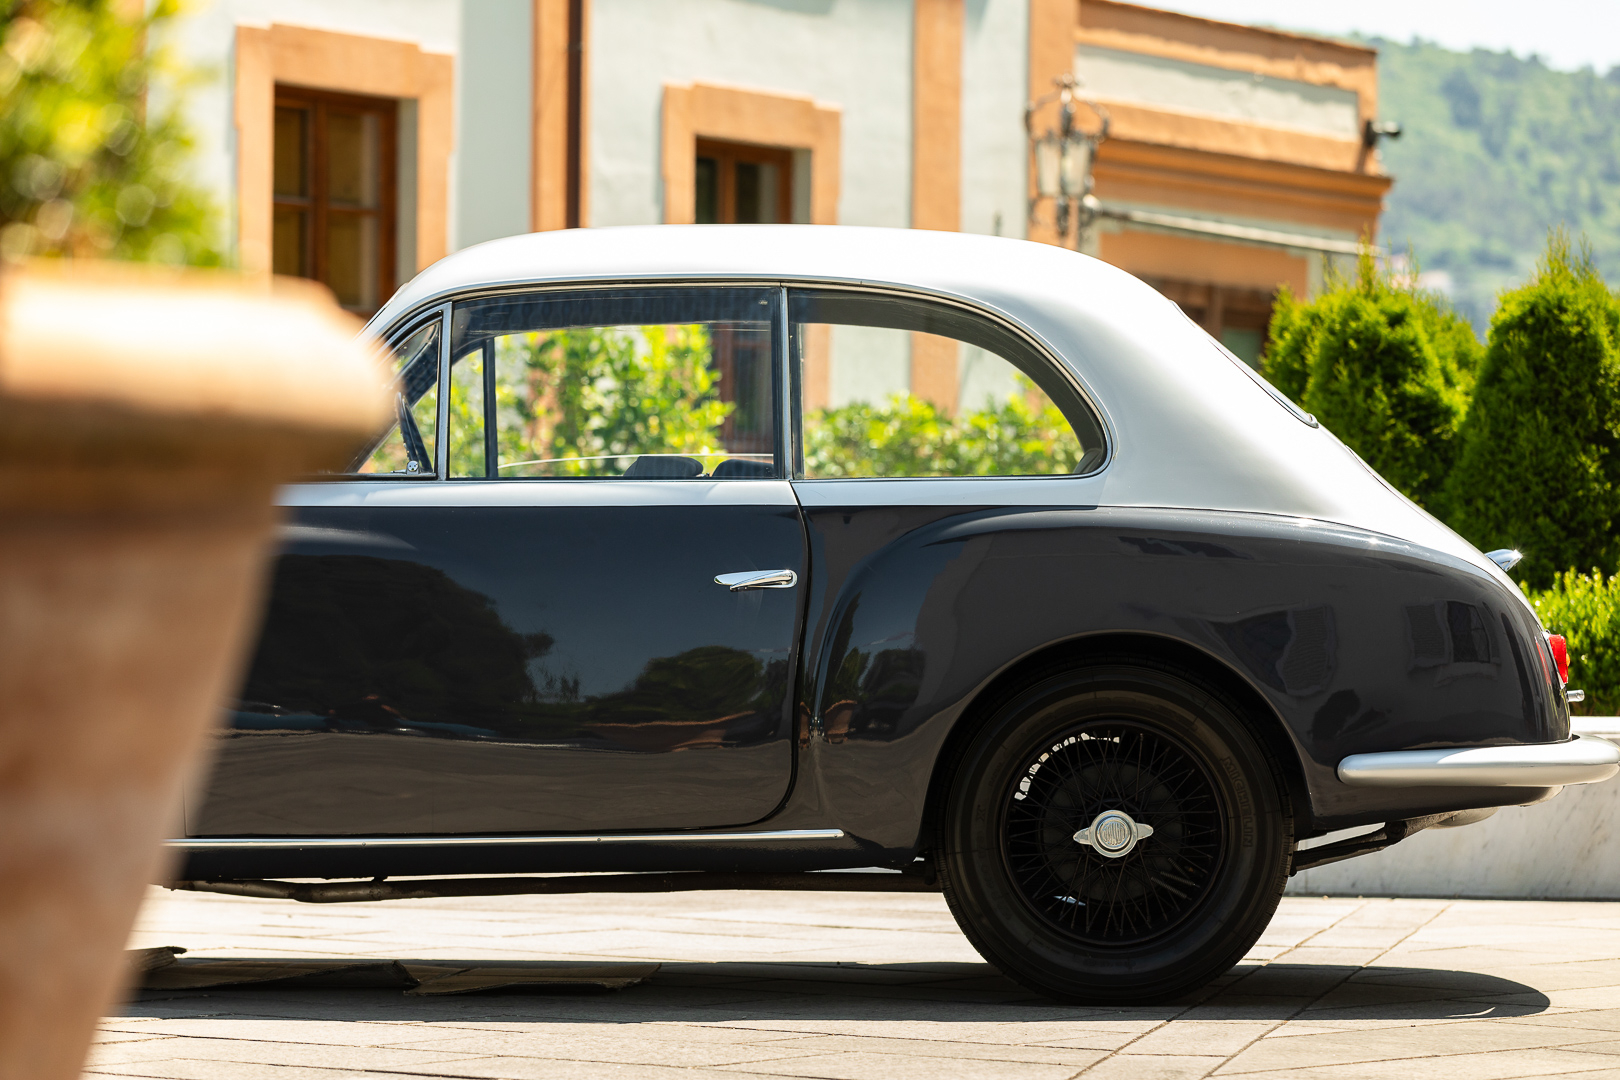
left=1338, top=735, right=1620, bottom=787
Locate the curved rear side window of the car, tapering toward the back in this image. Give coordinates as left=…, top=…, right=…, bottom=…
left=789, top=290, right=1105, bottom=479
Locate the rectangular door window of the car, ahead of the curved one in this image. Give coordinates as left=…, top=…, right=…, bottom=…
left=450, top=288, right=781, bottom=479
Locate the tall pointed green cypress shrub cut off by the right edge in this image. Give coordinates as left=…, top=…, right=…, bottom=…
left=1447, top=233, right=1620, bottom=588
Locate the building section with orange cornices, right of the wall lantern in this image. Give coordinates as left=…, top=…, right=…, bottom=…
left=1071, top=0, right=1390, bottom=363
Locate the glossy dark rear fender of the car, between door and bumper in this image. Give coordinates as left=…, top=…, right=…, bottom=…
left=784, top=505, right=1568, bottom=840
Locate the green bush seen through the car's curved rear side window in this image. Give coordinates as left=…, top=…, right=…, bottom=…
left=805, top=379, right=1081, bottom=478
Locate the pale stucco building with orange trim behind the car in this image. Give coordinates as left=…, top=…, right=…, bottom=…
left=178, top=0, right=1390, bottom=365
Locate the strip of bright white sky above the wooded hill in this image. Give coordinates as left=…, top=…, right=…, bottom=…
left=1149, top=0, right=1620, bottom=73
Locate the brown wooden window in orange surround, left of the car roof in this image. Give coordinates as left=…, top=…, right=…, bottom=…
left=271, top=86, right=399, bottom=316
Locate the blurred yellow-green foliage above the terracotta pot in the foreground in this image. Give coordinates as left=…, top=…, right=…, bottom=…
left=0, top=0, right=220, bottom=266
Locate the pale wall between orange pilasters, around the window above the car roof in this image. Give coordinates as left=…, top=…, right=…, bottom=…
left=586, top=0, right=912, bottom=227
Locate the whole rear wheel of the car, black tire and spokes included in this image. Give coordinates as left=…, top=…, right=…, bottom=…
left=933, top=662, right=1293, bottom=1004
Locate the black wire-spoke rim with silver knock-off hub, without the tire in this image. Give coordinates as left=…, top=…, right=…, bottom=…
left=1003, top=721, right=1225, bottom=946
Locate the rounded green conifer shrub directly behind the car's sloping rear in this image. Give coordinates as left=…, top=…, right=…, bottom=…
left=1264, top=251, right=1479, bottom=507
